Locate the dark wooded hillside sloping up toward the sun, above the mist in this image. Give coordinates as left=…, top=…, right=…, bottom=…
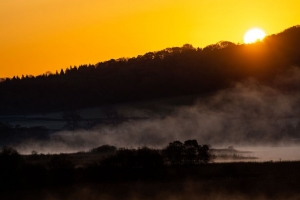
left=0, top=26, right=300, bottom=115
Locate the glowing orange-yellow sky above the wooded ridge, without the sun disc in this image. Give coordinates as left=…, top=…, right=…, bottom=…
left=0, top=0, right=300, bottom=77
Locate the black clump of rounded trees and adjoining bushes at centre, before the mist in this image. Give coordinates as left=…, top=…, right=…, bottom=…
left=100, top=140, right=211, bottom=168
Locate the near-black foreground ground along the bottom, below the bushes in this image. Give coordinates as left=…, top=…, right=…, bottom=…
left=0, top=162, right=300, bottom=200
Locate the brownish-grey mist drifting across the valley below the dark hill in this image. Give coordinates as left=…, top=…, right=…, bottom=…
left=16, top=68, right=300, bottom=161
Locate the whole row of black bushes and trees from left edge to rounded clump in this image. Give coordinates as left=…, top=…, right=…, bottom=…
left=0, top=140, right=211, bottom=190
